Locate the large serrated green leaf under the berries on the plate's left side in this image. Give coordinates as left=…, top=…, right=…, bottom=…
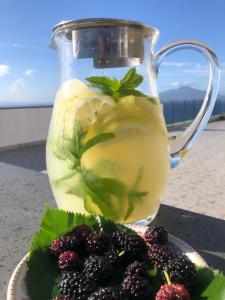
left=25, top=206, right=132, bottom=300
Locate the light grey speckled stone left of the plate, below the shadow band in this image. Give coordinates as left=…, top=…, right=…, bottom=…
left=0, top=163, right=55, bottom=300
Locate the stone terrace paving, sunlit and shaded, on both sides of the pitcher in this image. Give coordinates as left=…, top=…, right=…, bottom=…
left=0, top=122, right=225, bottom=300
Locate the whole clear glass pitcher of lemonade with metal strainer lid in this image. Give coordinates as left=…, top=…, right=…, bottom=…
left=46, top=19, right=219, bottom=223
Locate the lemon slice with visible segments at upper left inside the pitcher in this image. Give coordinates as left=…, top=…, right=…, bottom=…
left=56, top=91, right=116, bottom=137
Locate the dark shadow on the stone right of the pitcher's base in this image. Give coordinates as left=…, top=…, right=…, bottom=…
left=153, top=204, right=225, bottom=272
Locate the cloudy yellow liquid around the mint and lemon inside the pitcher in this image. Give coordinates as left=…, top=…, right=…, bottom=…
left=46, top=84, right=169, bottom=223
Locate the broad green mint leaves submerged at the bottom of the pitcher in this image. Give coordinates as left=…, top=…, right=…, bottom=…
left=67, top=169, right=148, bottom=221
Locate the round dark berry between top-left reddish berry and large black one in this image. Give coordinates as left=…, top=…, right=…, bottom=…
left=86, top=231, right=109, bottom=254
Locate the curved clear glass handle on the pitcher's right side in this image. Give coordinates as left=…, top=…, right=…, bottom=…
left=155, top=40, right=220, bottom=168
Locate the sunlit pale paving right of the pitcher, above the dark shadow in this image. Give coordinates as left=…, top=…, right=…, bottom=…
left=163, top=121, right=225, bottom=220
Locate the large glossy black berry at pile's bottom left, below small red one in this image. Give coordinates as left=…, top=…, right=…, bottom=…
left=59, top=271, right=96, bottom=300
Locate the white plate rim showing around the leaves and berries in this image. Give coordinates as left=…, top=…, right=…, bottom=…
left=7, top=225, right=208, bottom=300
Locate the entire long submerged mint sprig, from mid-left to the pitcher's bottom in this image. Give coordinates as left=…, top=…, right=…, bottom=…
left=51, top=121, right=148, bottom=221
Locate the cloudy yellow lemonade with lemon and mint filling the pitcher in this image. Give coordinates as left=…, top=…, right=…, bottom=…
left=47, top=71, right=169, bottom=223
